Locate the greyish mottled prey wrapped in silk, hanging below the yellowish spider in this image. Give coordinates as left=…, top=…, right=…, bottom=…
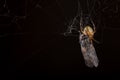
left=79, top=34, right=99, bottom=67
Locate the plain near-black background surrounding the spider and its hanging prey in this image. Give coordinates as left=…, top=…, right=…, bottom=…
left=0, top=0, right=120, bottom=76
